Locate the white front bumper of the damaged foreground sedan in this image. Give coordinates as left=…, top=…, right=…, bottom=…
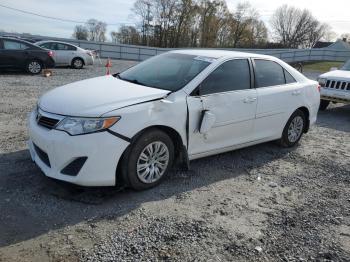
left=28, top=112, right=129, bottom=186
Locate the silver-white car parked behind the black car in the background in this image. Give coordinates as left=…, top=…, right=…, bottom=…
left=35, top=40, right=94, bottom=69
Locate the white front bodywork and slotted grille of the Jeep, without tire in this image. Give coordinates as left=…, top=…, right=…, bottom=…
left=319, top=70, right=350, bottom=103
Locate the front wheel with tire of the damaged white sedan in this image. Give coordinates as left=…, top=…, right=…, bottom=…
left=121, top=129, right=174, bottom=190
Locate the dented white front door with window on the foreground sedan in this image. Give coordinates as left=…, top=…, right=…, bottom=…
left=187, top=59, right=257, bottom=158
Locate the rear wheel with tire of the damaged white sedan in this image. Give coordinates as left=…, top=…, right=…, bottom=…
left=280, top=110, right=306, bottom=147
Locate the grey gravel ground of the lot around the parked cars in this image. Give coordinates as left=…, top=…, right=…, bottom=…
left=0, top=61, right=350, bottom=261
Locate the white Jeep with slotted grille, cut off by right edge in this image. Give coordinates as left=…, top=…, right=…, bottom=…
left=318, top=60, right=350, bottom=110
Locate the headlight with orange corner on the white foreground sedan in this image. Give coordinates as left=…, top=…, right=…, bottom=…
left=55, top=117, right=120, bottom=136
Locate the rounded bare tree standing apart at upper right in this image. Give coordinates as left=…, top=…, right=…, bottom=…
left=271, top=5, right=328, bottom=48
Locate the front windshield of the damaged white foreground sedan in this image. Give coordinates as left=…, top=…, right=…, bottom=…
left=118, top=53, right=212, bottom=91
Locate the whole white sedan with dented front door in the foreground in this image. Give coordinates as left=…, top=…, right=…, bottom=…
left=29, top=50, right=320, bottom=190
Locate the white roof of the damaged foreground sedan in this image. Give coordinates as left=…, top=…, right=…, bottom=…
left=171, top=49, right=274, bottom=59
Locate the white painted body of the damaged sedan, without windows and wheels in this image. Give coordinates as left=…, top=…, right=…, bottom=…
left=29, top=50, right=320, bottom=186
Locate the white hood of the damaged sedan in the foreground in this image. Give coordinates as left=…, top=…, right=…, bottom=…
left=39, top=76, right=170, bottom=117
